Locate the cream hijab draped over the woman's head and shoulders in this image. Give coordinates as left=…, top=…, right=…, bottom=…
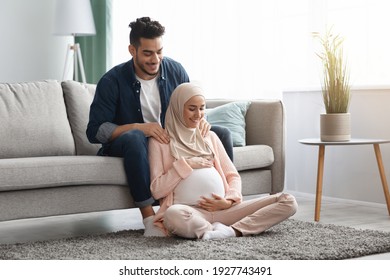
left=165, top=83, right=213, bottom=159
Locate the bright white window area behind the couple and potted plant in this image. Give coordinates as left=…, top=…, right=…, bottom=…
left=112, top=0, right=390, bottom=99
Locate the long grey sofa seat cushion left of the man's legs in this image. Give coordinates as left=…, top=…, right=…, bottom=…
left=0, top=156, right=127, bottom=191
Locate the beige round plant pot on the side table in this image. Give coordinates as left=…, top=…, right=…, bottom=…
left=320, top=113, right=351, bottom=142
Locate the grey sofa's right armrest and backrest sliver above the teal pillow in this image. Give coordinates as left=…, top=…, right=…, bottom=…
left=207, top=99, right=285, bottom=193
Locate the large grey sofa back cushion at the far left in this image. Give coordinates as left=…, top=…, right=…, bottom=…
left=0, top=81, right=75, bottom=158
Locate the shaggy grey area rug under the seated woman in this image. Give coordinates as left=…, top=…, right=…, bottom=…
left=0, top=219, right=390, bottom=260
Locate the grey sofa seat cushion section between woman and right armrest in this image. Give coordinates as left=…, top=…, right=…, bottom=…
left=233, top=145, right=274, bottom=171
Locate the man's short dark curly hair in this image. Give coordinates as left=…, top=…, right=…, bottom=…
left=129, top=17, right=165, bottom=48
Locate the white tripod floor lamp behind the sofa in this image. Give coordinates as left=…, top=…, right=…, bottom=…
left=54, top=0, right=96, bottom=83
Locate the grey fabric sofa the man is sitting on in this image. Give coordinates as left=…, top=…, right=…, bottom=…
left=0, top=81, right=284, bottom=221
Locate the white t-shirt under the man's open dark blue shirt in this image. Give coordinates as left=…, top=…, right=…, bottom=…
left=137, top=76, right=161, bottom=123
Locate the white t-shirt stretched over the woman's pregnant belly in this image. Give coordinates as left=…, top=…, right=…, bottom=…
left=173, top=167, right=225, bottom=205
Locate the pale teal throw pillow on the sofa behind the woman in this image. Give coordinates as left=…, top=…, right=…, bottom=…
left=206, top=101, right=251, bottom=147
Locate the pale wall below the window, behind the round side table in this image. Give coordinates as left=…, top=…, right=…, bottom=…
left=283, top=87, right=390, bottom=203
